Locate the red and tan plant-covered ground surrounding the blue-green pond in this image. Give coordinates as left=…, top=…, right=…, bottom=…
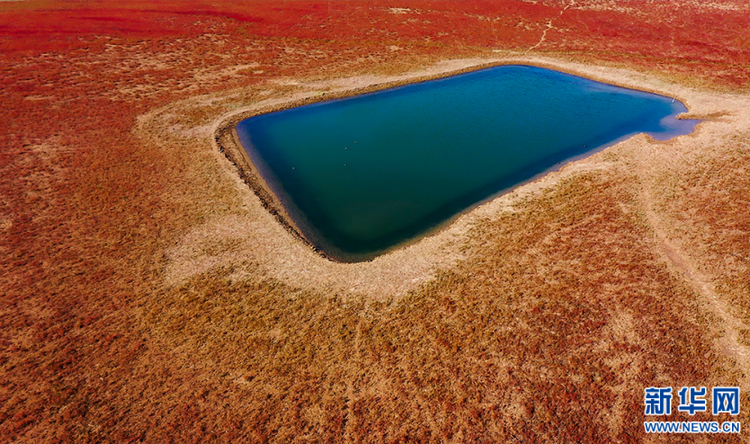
left=0, top=1, right=750, bottom=443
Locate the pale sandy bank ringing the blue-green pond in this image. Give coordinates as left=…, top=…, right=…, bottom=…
left=140, top=55, right=750, bottom=299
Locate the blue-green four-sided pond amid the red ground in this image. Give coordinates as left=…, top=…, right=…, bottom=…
left=236, top=65, right=697, bottom=262
